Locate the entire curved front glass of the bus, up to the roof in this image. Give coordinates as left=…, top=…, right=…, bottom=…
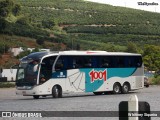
left=16, top=52, right=49, bottom=87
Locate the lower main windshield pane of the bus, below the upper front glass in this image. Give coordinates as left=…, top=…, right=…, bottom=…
left=16, top=60, right=39, bottom=86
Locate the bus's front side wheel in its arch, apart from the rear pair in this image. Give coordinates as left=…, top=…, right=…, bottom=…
left=52, top=85, right=62, bottom=98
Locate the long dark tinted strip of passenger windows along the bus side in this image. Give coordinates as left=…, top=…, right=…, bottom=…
left=56, top=56, right=142, bottom=70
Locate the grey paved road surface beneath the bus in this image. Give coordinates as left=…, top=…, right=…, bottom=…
left=0, top=86, right=160, bottom=120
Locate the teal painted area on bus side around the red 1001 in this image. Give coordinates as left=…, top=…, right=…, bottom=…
left=80, top=68, right=136, bottom=92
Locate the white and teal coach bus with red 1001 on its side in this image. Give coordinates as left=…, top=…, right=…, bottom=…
left=16, top=51, right=144, bottom=99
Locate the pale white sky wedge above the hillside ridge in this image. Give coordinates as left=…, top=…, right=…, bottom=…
left=86, top=0, right=160, bottom=13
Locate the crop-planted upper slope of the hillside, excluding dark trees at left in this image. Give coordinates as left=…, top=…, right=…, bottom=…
left=16, top=0, right=160, bottom=49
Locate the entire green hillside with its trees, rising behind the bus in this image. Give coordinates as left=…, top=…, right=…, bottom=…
left=0, top=0, right=160, bottom=69
